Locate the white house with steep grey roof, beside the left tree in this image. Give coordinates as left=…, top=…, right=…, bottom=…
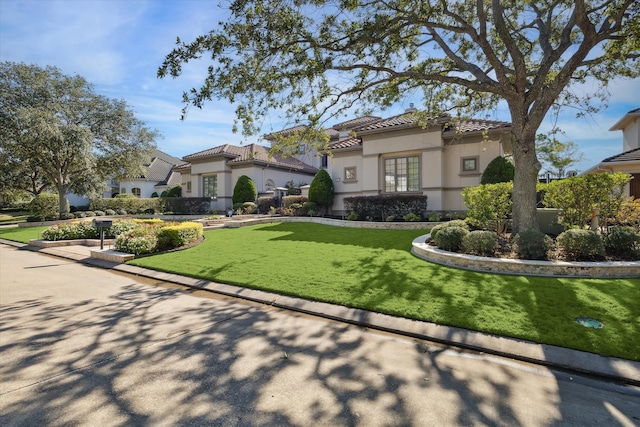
left=115, top=150, right=182, bottom=198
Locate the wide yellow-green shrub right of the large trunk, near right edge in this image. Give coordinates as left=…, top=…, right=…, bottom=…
left=543, top=172, right=631, bottom=230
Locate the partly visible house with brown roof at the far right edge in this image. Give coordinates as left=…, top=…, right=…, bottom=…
left=583, top=108, right=640, bottom=199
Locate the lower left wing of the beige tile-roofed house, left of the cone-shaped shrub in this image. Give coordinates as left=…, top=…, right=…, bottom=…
left=173, top=144, right=318, bottom=211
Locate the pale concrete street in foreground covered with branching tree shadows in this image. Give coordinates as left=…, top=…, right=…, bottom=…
left=0, top=245, right=640, bottom=426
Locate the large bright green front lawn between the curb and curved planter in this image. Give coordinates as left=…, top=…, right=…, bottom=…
left=130, top=223, right=640, bottom=360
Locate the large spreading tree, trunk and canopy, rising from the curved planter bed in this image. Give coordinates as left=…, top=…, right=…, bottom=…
left=158, top=0, right=640, bottom=231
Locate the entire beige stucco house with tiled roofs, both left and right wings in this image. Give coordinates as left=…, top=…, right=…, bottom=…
left=174, top=109, right=511, bottom=215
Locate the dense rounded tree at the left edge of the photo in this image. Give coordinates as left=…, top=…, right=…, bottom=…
left=0, top=62, right=158, bottom=213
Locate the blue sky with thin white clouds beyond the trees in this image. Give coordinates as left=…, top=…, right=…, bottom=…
left=0, top=0, right=640, bottom=174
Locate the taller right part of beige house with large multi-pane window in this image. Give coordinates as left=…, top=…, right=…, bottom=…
left=272, top=109, right=511, bottom=215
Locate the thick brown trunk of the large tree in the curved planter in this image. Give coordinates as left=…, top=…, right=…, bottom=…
left=512, top=136, right=542, bottom=234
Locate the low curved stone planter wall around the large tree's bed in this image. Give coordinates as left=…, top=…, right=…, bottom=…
left=411, top=234, right=640, bottom=279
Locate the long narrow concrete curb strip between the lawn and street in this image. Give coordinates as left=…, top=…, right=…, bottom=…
left=0, top=239, right=640, bottom=386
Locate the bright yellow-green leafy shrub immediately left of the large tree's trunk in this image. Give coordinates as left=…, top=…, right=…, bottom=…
left=462, top=182, right=513, bottom=234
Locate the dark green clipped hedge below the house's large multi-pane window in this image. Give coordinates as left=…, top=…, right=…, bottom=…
left=344, top=194, right=427, bottom=221
